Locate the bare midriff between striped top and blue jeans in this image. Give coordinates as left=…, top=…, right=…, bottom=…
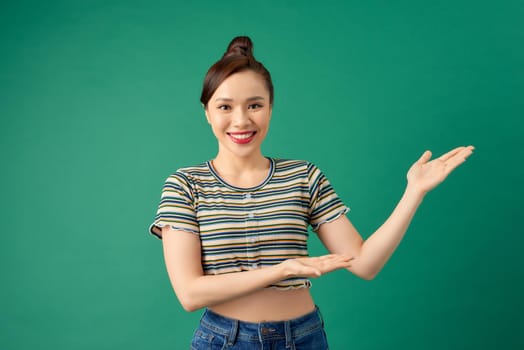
left=209, top=288, right=315, bottom=322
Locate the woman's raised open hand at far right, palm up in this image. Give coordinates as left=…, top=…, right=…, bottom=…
left=407, top=146, right=475, bottom=194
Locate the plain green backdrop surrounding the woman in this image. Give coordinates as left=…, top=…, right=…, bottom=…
left=0, top=0, right=524, bottom=350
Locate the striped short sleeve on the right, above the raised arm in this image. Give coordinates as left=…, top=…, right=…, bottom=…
left=308, top=163, right=349, bottom=232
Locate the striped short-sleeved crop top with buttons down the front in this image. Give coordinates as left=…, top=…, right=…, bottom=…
left=149, top=158, right=349, bottom=289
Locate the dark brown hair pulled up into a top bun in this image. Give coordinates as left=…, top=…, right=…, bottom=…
left=200, top=36, right=273, bottom=107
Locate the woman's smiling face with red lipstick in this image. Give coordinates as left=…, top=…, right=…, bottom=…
left=206, top=70, right=272, bottom=161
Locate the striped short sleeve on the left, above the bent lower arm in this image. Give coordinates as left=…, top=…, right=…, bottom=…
left=149, top=172, right=200, bottom=239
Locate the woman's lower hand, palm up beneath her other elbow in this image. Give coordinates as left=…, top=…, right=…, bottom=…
left=280, top=254, right=354, bottom=278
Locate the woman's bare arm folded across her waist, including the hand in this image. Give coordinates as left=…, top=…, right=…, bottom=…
left=162, top=226, right=352, bottom=311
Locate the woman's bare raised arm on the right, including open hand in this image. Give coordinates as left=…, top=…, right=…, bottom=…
left=317, top=146, right=474, bottom=280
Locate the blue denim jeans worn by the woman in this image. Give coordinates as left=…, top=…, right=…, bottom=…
left=191, top=307, right=328, bottom=350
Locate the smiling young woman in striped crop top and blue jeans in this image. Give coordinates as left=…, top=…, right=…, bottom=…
left=150, top=37, right=473, bottom=350
